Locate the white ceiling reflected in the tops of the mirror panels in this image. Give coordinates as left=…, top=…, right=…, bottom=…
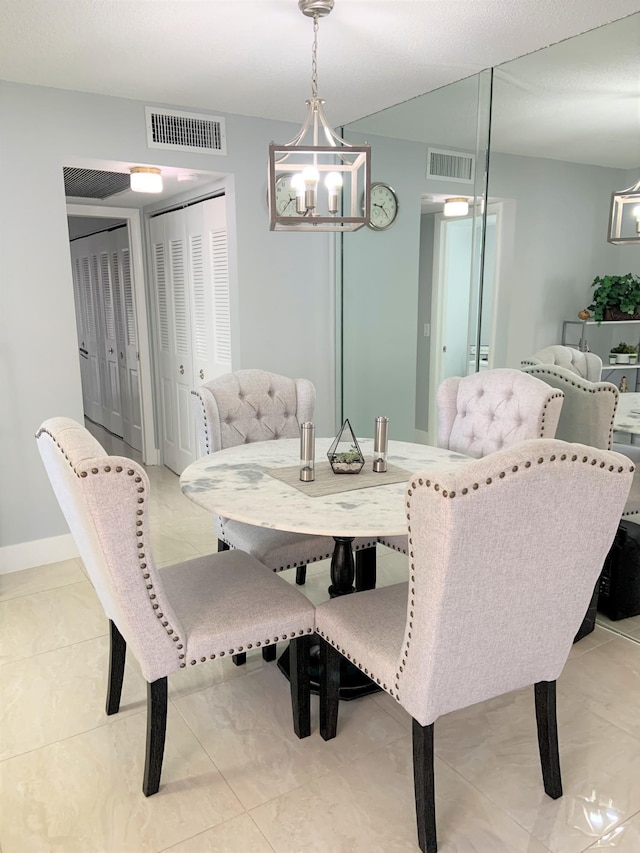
left=351, top=13, right=640, bottom=169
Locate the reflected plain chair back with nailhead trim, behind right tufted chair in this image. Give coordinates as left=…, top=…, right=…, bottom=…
left=523, top=362, right=618, bottom=450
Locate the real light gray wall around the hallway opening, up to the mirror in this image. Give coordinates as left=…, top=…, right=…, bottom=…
left=0, top=82, right=335, bottom=546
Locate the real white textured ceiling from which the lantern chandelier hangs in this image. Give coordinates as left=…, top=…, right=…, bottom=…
left=0, top=0, right=640, bottom=125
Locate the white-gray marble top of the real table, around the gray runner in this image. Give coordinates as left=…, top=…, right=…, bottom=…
left=180, top=438, right=470, bottom=536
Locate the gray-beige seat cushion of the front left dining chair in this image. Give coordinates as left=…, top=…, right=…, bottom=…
left=160, top=551, right=315, bottom=667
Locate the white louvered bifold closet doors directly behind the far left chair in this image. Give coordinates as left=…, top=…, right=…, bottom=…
left=150, top=197, right=231, bottom=474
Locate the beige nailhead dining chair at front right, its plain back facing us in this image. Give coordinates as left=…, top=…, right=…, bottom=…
left=316, top=439, right=634, bottom=853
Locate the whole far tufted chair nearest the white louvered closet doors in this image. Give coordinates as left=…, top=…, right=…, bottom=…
left=191, top=370, right=376, bottom=624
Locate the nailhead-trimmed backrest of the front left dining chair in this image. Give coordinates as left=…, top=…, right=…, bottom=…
left=36, top=418, right=184, bottom=681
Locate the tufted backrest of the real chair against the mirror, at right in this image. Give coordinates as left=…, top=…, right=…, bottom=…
left=437, top=368, right=564, bottom=457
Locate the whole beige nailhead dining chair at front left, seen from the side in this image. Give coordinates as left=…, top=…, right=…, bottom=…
left=37, top=418, right=314, bottom=796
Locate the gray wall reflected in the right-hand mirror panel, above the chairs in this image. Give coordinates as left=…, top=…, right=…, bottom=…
left=489, top=154, right=640, bottom=367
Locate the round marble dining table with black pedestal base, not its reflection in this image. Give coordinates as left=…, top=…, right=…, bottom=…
left=180, top=438, right=469, bottom=699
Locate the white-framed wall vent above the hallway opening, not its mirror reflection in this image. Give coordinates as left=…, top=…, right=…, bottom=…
left=145, top=107, right=227, bottom=154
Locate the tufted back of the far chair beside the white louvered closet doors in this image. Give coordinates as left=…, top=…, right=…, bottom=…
left=191, top=370, right=316, bottom=456
